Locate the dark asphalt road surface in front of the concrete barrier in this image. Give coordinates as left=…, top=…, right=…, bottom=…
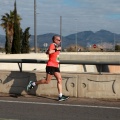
left=0, top=95, right=120, bottom=120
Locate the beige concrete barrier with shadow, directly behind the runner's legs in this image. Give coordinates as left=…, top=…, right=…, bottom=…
left=0, top=71, right=120, bottom=99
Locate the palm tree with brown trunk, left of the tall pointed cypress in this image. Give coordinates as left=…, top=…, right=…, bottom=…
left=0, top=11, right=21, bottom=53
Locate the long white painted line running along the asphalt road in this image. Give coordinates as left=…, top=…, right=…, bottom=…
left=0, top=100, right=120, bottom=110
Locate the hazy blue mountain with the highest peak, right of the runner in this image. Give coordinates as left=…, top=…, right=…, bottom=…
left=66, top=30, right=120, bottom=46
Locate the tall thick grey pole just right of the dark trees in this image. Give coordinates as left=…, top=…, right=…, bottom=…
left=34, top=0, right=37, bottom=53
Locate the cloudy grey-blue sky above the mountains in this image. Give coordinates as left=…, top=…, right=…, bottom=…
left=0, top=0, right=120, bottom=36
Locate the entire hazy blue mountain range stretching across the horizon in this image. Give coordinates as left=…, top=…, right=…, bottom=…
left=0, top=30, right=120, bottom=48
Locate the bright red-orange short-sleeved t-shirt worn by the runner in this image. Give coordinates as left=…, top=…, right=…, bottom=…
left=47, top=43, right=60, bottom=67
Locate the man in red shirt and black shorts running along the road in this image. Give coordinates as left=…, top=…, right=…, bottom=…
left=27, top=35, right=69, bottom=101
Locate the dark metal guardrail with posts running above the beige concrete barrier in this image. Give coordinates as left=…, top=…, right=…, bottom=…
left=0, top=59, right=120, bottom=74
